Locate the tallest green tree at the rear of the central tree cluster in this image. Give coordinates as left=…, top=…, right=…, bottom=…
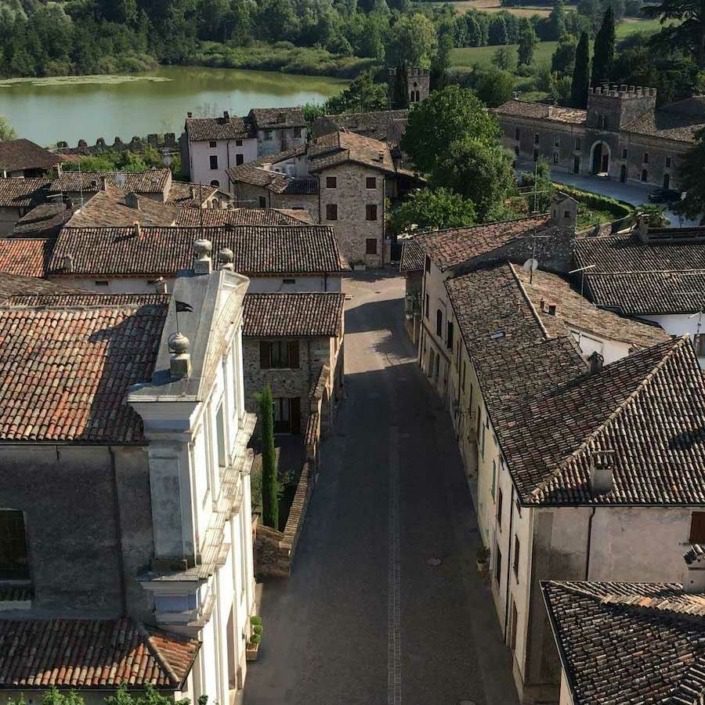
left=401, top=86, right=499, bottom=173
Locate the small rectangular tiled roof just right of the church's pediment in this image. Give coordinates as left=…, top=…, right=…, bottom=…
left=242, top=293, right=345, bottom=338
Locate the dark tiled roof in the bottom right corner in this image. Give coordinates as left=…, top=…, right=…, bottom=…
left=542, top=582, right=705, bottom=705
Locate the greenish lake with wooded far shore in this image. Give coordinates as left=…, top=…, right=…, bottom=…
left=0, top=66, right=347, bottom=146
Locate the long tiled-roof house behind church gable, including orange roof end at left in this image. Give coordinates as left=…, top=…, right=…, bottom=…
left=9, top=224, right=348, bottom=294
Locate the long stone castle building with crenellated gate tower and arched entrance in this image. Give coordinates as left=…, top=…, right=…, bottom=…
left=494, top=85, right=705, bottom=189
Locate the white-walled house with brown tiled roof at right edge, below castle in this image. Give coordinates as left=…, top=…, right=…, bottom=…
left=574, top=219, right=705, bottom=366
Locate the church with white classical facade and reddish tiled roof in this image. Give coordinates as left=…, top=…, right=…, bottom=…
left=0, top=260, right=255, bottom=703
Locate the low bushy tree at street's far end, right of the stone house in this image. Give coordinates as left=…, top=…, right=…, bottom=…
left=389, top=188, right=476, bottom=233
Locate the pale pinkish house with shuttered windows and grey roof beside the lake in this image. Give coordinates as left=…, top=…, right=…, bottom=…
left=180, top=108, right=307, bottom=190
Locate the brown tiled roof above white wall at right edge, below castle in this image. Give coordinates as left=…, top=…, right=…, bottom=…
left=575, top=234, right=705, bottom=315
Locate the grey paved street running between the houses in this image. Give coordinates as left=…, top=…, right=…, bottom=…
left=245, top=274, right=517, bottom=705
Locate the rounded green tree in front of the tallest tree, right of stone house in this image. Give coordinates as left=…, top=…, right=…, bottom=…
left=432, top=137, right=515, bottom=221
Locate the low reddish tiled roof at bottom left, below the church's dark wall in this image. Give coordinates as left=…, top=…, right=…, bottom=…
left=0, top=618, right=200, bottom=690
